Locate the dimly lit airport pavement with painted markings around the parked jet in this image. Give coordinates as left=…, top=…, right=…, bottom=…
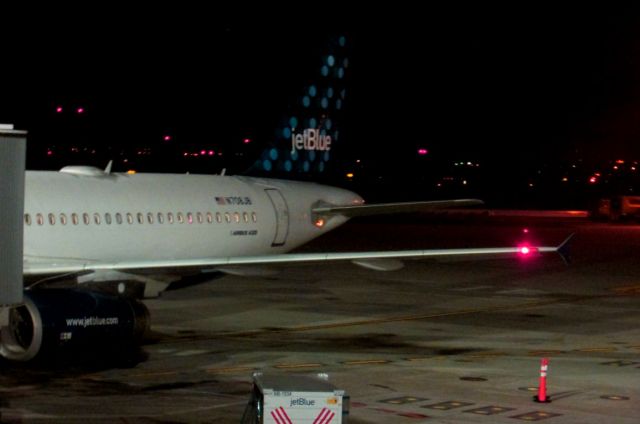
left=0, top=216, right=640, bottom=424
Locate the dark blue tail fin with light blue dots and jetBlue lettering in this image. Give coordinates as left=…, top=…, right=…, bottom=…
left=245, top=35, right=349, bottom=179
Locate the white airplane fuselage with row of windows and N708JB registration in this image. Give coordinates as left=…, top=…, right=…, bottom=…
left=24, top=171, right=362, bottom=263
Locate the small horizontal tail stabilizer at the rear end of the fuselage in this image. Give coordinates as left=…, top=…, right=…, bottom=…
left=312, top=199, right=484, bottom=218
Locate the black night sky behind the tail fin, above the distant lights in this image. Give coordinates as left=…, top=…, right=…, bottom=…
left=0, top=3, right=640, bottom=196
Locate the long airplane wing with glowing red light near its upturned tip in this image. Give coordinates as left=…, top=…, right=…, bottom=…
left=24, top=234, right=573, bottom=276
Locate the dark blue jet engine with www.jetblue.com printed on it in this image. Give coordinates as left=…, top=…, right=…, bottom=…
left=0, top=289, right=149, bottom=361
